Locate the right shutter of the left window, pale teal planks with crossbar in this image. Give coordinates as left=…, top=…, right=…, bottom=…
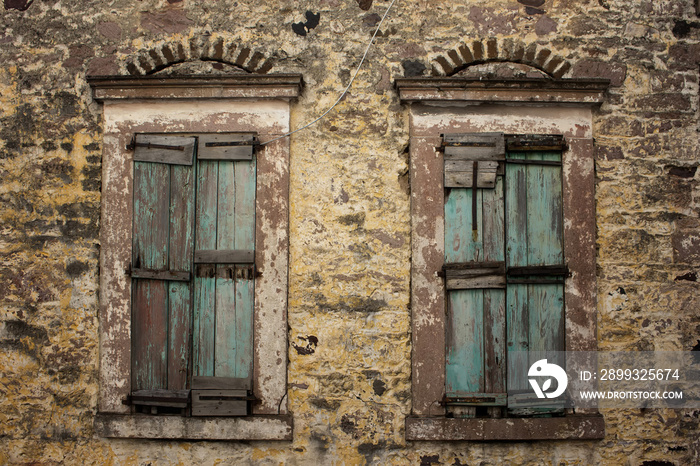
left=193, top=135, right=256, bottom=394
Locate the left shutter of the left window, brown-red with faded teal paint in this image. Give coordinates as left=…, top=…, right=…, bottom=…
left=131, top=135, right=195, bottom=394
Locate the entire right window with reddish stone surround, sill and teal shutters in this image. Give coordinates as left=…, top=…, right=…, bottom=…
left=396, top=78, right=607, bottom=441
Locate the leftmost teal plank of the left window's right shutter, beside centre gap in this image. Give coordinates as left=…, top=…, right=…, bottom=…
left=193, top=161, right=219, bottom=377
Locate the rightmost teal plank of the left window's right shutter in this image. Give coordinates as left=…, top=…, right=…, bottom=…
left=233, top=160, right=256, bottom=378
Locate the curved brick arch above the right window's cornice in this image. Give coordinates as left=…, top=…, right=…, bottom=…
left=431, top=38, right=571, bottom=79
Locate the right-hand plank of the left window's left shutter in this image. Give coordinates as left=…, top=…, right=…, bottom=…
left=168, top=165, right=195, bottom=390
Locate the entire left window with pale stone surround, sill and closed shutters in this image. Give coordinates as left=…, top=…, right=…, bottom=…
left=89, top=74, right=301, bottom=440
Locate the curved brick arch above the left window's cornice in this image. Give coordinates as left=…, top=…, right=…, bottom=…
left=123, top=35, right=273, bottom=76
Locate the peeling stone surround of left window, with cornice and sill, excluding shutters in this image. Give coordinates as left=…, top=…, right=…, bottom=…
left=88, top=75, right=302, bottom=440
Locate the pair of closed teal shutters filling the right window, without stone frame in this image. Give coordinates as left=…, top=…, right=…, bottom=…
left=443, top=133, right=567, bottom=418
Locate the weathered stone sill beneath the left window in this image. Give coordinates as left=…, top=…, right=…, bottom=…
left=95, top=414, right=293, bottom=440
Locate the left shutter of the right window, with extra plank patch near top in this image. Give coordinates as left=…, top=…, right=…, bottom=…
left=444, top=133, right=506, bottom=415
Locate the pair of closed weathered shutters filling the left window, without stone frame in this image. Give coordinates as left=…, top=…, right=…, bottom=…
left=129, top=133, right=256, bottom=416
